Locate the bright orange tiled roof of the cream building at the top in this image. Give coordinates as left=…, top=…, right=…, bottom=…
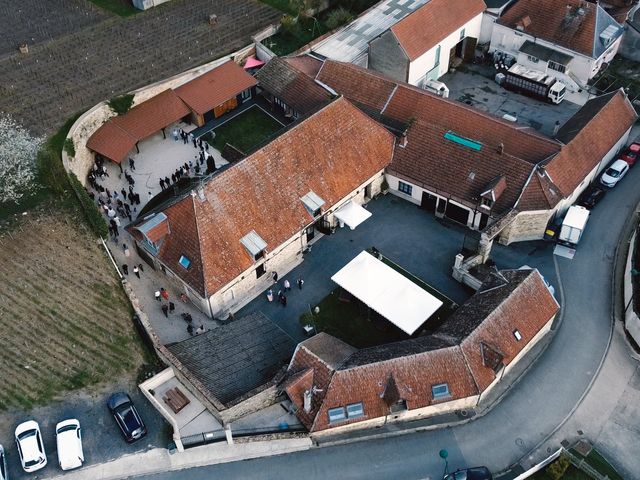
left=391, top=0, right=487, bottom=61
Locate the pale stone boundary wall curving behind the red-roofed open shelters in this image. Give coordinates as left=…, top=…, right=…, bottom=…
left=62, top=44, right=255, bottom=186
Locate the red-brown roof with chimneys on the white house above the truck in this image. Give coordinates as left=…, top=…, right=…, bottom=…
left=496, top=0, right=598, bottom=57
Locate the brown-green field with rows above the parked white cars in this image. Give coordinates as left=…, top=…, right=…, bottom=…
left=0, top=212, right=143, bottom=410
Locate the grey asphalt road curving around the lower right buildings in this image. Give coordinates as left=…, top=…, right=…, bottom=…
left=138, top=146, right=640, bottom=480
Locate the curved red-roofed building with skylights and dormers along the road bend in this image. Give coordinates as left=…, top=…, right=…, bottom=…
left=281, top=270, right=559, bottom=433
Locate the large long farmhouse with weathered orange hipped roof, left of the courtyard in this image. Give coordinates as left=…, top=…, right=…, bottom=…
left=132, top=98, right=394, bottom=316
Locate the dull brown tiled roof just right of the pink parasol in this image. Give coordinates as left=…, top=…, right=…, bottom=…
left=256, top=57, right=331, bottom=115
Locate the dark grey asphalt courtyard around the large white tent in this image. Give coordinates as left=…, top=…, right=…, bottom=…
left=235, top=194, right=555, bottom=341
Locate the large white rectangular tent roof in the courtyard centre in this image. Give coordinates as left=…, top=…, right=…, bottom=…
left=331, top=252, right=442, bottom=335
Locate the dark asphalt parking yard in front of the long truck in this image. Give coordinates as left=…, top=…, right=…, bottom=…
left=440, top=65, right=580, bottom=136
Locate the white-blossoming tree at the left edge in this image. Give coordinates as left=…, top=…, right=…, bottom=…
left=0, top=113, right=42, bottom=203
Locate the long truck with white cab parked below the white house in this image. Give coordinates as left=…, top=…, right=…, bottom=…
left=496, top=63, right=567, bottom=105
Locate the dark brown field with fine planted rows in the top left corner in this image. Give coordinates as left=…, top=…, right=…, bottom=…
left=0, top=0, right=280, bottom=133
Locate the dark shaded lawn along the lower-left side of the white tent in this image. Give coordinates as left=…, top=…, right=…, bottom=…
left=300, top=288, right=409, bottom=348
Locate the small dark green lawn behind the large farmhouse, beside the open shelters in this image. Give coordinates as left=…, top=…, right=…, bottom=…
left=204, top=107, right=283, bottom=153
